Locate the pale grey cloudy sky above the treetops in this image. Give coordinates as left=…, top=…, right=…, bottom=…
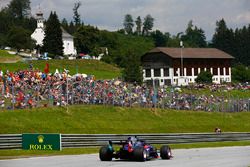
left=0, top=0, right=250, bottom=40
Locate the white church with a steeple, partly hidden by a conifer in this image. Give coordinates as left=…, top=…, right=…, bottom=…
left=31, top=10, right=76, bottom=55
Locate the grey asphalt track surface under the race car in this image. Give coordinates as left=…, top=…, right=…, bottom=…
left=0, top=146, right=250, bottom=167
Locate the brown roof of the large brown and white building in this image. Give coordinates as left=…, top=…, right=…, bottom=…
left=145, top=47, right=234, bottom=59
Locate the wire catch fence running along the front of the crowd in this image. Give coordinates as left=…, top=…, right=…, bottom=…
left=0, top=79, right=250, bottom=112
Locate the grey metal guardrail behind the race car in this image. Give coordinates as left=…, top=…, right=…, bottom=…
left=0, top=133, right=250, bottom=149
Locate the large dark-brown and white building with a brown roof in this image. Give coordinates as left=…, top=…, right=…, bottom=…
left=141, top=47, right=233, bottom=86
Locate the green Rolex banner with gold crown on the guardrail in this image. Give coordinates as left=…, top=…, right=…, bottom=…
left=22, top=133, right=61, bottom=150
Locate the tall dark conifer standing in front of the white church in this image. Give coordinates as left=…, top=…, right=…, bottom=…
left=43, top=12, right=63, bottom=57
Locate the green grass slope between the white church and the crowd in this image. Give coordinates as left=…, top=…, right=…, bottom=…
left=0, top=59, right=121, bottom=79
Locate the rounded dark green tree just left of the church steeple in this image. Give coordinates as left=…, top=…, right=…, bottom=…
left=7, top=26, right=35, bottom=52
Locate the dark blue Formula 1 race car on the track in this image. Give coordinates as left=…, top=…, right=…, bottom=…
left=99, top=136, right=172, bottom=161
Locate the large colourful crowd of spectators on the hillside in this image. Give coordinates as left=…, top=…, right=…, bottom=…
left=0, top=68, right=250, bottom=111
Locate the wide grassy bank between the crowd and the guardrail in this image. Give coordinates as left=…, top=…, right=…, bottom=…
left=0, top=105, right=250, bottom=134
